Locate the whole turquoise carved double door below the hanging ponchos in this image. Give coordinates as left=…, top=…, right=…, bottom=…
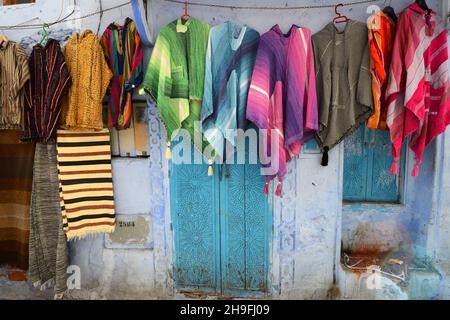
left=170, top=136, right=272, bottom=296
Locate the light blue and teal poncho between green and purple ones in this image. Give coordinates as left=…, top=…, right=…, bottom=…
left=201, top=22, right=259, bottom=159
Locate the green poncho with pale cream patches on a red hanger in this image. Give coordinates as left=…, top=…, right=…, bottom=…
left=144, top=17, right=210, bottom=149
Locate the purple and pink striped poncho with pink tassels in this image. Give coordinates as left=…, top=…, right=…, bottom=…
left=247, top=25, right=319, bottom=195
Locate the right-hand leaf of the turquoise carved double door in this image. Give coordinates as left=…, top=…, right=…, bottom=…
left=220, top=164, right=272, bottom=296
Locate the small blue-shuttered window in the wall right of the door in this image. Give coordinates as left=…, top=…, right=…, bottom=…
left=344, top=125, right=404, bottom=203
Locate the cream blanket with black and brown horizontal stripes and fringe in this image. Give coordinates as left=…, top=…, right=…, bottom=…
left=57, top=129, right=115, bottom=240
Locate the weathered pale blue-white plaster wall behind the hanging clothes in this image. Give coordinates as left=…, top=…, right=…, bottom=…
left=0, top=0, right=450, bottom=299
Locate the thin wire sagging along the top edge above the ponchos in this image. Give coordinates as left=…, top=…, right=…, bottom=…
left=164, top=0, right=382, bottom=10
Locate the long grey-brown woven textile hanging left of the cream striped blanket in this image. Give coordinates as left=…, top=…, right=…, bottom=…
left=29, top=142, right=68, bottom=296
